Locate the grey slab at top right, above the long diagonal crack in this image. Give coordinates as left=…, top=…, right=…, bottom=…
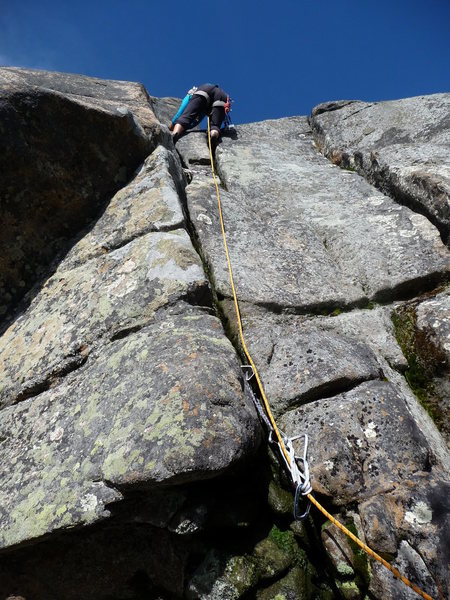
left=311, top=94, right=450, bottom=241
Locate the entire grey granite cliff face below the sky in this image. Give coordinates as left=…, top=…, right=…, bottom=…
left=0, top=69, right=450, bottom=600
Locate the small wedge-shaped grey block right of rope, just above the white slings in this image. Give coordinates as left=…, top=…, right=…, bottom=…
left=236, top=314, right=382, bottom=416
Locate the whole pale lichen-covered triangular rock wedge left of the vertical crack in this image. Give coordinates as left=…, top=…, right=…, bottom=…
left=0, top=70, right=260, bottom=547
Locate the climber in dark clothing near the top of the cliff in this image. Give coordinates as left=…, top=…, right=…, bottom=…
left=169, top=83, right=230, bottom=146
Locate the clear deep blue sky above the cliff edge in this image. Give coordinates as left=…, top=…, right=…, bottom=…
left=0, top=0, right=450, bottom=123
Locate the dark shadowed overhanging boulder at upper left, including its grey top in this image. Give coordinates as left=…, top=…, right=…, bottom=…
left=0, top=68, right=158, bottom=315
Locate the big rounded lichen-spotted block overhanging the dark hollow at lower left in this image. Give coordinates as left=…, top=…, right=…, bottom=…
left=0, top=311, right=259, bottom=547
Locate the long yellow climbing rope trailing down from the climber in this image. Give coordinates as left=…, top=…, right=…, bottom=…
left=208, top=117, right=433, bottom=600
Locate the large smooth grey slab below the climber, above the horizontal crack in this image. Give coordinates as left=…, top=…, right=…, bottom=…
left=186, top=117, right=450, bottom=311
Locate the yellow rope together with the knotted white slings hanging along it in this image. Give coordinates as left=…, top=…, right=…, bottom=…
left=207, top=117, right=433, bottom=600
